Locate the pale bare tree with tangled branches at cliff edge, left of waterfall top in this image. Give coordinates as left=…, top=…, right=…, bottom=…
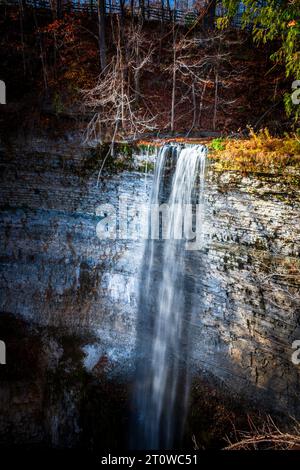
left=83, top=18, right=156, bottom=143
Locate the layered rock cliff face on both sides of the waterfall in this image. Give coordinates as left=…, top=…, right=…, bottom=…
left=0, top=137, right=300, bottom=441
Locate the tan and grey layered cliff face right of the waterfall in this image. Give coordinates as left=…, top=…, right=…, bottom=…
left=193, top=168, right=300, bottom=414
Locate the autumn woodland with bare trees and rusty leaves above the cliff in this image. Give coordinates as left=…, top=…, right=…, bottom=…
left=0, top=0, right=300, bottom=140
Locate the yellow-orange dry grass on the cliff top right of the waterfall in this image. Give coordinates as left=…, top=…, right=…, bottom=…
left=209, top=129, right=300, bottom=173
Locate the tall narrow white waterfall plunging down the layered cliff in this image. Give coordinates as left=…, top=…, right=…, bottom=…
left=132, top=144, right=206, bottom=449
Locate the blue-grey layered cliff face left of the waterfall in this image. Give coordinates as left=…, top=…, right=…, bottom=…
left=1, top=135, right=150, bottom=369
